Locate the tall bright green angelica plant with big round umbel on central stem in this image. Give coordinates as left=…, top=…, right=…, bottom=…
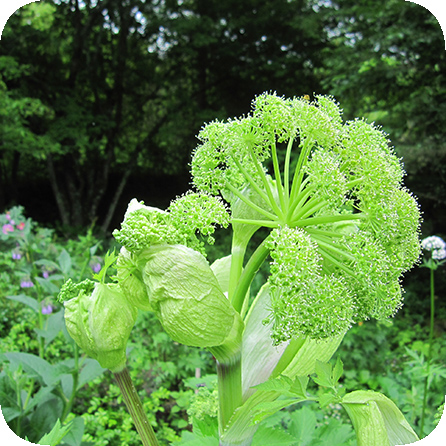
left=59, top=93, right=420, bottom=446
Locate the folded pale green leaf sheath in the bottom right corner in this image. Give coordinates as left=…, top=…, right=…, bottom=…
left=341, top=390, right=418, bottom=446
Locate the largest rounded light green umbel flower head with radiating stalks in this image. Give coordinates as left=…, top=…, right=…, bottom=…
left=192, top=94, right=420, bottom=344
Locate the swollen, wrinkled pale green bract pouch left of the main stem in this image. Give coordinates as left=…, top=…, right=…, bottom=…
left=142, top=245, right=243, bottom=358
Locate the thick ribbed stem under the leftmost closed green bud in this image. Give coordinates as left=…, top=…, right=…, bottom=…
left=113, top=367, right=159, bottom=446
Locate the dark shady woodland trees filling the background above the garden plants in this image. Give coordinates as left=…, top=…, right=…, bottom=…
left=0, top=0, right=446, bottom=240
